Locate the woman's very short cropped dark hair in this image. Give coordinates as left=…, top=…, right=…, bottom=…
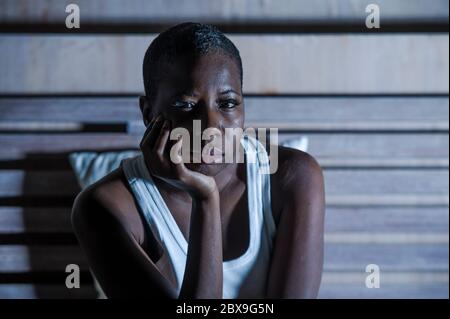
left=142, top=22, right=243, bottom=98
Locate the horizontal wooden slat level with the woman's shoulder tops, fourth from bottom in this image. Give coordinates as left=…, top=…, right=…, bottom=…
left=0, top=169, right=449, bottom=196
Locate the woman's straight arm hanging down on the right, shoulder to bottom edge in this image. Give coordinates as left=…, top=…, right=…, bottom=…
left=267, top=152, right=325, bottom=298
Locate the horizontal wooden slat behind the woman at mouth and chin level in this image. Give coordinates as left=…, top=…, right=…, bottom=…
left=0, top=133, right=449, bottom=161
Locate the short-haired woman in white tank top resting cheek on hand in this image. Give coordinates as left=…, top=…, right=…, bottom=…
left=72, top=23, right=324, bottom=298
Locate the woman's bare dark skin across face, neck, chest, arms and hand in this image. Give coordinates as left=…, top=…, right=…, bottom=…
left=72, top=53, right=324, bottom=298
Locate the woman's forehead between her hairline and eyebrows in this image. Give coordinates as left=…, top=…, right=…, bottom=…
left=160, top=53, right=241, bottom=93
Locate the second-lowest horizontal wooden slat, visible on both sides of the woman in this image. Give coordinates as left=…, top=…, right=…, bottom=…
left=0, top=243, right=448, bottom=273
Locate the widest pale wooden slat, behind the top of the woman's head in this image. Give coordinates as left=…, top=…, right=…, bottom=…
left=0, top=34, right=449, bottom=94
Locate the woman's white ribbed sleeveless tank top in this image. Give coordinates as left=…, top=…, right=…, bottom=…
left=122, top=136, right=276, bottom=298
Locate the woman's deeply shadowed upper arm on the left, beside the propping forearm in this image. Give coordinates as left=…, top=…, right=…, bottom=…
left=72, top=190, right=176, bottom=298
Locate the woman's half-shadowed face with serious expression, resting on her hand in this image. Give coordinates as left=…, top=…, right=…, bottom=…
left=141, top=53, right=244, bottom=174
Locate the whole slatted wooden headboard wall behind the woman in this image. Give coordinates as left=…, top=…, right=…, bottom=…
left=0, top=0, right=449, bottom=298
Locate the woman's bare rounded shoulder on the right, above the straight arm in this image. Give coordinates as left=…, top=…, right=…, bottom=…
left=271, top=146, right=324, bottom=224
